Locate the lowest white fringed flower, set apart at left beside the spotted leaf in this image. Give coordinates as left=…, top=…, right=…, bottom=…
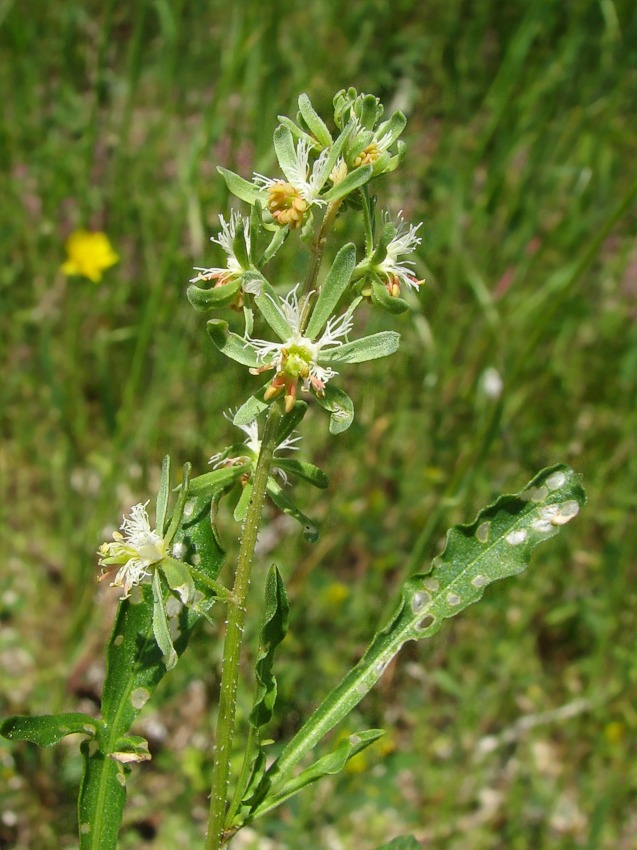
left=98, top=502, right=167, bottom=599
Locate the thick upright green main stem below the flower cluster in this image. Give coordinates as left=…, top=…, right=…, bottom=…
left=205, top=402, right=281, bottom=850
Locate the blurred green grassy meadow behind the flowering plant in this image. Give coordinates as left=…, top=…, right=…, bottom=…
left=0, top=0, right=637, bottom=850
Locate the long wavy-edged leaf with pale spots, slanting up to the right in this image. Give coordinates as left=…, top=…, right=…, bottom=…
left=268, top=464, right=586, bottom=796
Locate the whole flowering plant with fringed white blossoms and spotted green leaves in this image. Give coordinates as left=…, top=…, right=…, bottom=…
left=2, top=89, right=584, bottom=850
